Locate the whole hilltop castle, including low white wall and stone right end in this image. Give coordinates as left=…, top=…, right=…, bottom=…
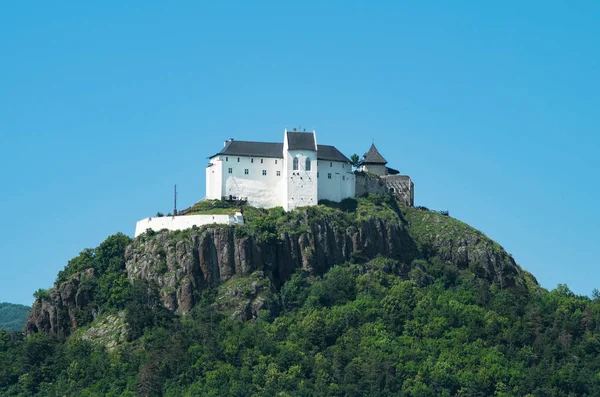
left=135, top=129, right=414, bottom=237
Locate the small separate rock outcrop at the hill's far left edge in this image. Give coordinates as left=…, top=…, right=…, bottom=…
left=25, top=269, right=94, bottom=336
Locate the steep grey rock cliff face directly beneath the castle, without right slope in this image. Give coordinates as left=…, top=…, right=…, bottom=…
left=125, top=213, right=415, bottom=313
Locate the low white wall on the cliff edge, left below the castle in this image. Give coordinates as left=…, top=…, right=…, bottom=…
left=134, top=213, right=244, bottom=237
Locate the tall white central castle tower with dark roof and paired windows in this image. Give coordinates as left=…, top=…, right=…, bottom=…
left=282, top=128, right=318, bottom=211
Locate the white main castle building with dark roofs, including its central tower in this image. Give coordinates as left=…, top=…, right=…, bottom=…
left=206, top=129, right=356, bottom=211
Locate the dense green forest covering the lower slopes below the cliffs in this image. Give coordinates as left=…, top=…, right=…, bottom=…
left=0, top=257, right=600, bottom=396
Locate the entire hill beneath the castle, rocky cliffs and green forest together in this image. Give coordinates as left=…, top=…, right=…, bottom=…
left=0, top=197, right=600, bottom=396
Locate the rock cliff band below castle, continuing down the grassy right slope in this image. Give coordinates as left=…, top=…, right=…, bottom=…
left=125, top=209, right=523, bottom=318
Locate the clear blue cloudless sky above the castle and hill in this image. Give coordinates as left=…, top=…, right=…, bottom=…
left=0, top=0, right=600, bottom=304
